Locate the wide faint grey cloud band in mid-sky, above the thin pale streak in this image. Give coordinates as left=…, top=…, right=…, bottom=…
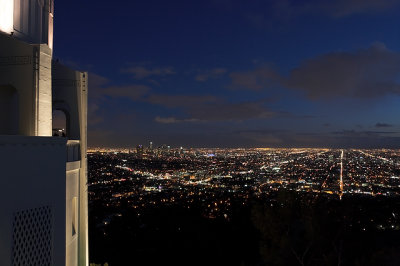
left=146, top=94, right=276, bottom=123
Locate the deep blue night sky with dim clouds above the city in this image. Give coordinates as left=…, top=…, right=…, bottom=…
left=54, top=0, right=400, bottom=148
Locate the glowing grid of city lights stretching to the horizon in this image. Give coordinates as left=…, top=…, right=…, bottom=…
left=89, top=146, right=400, bottom=218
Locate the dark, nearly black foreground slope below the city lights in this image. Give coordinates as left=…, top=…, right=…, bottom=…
left=89, top=192, right=400, bottom=265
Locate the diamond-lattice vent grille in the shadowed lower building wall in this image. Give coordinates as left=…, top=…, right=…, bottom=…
left=13, top=206, right=53, bottom=266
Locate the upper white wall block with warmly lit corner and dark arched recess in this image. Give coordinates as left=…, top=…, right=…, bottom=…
left=0, top=33, right=52, bottom=136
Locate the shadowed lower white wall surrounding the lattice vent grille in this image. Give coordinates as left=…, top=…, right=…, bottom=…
left=0, top=136, right=66, bottom=265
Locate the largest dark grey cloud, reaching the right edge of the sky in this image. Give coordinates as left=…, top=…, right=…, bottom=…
left=230, top=43, right=400, bottom=100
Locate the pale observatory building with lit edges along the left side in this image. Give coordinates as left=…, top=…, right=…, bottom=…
left=0, top=0, right=88, bottom=265
